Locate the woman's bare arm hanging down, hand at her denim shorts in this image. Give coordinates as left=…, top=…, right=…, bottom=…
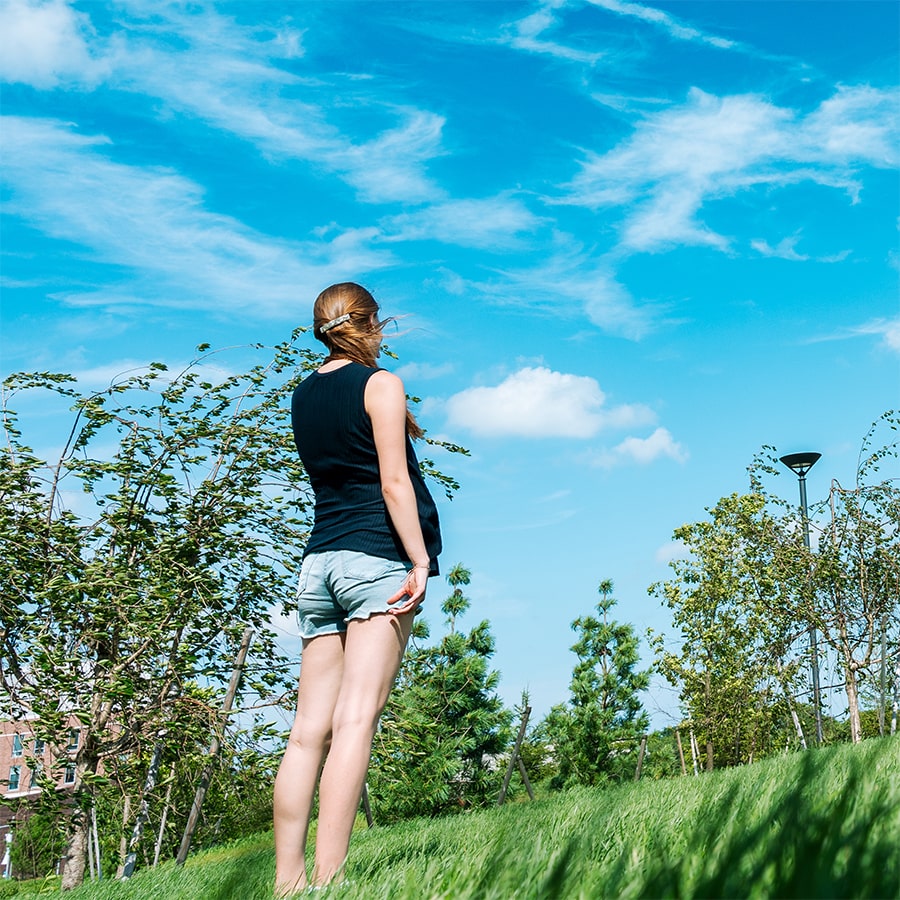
left=365, top=370, right=430, bottom=613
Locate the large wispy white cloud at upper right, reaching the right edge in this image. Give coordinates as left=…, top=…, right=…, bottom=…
left=566, top=86, right=900, bottom=255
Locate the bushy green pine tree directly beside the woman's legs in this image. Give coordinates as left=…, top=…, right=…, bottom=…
left=370, top=565, right=511, bottom=821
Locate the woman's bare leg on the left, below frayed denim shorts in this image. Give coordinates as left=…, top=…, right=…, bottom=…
left=274, top=634, right=345, bottom=897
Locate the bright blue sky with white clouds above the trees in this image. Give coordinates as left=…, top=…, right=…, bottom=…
left=0, top=0, right=900, bottom=726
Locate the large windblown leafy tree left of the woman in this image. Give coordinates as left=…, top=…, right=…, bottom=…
left=0, top=329, right=464, bottom=888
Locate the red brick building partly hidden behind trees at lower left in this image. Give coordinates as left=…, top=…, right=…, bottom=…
left=0, top=716, right=81, bottom=878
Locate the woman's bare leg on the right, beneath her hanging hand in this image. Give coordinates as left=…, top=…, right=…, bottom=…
left=313, top=614, right=413, bottom=884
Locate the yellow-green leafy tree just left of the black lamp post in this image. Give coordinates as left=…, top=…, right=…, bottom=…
left=650, top=494, right=805, bottom=769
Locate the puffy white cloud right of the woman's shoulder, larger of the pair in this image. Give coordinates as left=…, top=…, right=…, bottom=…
left=446, top=367, right=655, bottom=438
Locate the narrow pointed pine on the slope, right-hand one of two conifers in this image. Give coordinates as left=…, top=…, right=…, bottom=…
left=542, top=579, right=650, bottom=785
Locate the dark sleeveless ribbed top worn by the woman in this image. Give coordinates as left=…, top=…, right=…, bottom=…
left=291, top=362, right=441, bottom=575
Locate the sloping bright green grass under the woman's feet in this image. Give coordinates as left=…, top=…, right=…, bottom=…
left=10, top=738, right=900, bottom=900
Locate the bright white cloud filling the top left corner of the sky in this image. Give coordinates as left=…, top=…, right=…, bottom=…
left=0, top=0, right=108, bottom=88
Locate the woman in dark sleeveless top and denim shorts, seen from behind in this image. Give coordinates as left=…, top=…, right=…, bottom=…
left=275, top=282, right=441, bottom=897
